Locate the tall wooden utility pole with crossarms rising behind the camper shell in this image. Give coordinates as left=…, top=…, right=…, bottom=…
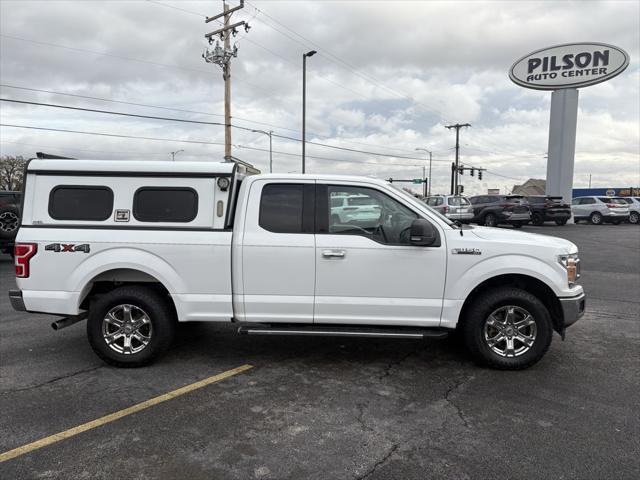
left=202, top=0, right=250, bottom=162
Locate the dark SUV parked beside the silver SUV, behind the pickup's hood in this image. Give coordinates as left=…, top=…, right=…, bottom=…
left=469, top=195, right=531, bottom=228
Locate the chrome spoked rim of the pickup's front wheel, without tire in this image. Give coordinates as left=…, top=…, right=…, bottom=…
left=483, top=305, right=537, bottom=358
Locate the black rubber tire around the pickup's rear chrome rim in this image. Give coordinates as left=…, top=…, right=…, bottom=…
left=87, top=286, right=177, bottom=367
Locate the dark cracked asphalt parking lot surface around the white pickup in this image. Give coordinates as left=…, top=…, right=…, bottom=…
left=0, top=224, right=640, bottom=480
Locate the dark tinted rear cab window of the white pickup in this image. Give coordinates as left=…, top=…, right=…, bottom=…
left=258, top=184, right=304, bottom=233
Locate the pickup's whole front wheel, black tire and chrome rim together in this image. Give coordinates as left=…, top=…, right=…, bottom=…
left=461, top=287, right=553, bottom=370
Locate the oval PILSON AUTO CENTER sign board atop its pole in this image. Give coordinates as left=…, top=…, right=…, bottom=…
left=509, top=43, right=629, bottom=90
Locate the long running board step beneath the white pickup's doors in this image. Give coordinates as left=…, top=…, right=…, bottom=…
left=238, top=325, right=449, bottom=339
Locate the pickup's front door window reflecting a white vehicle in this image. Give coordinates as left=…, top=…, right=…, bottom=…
left=328, top=185, right=418, bottom=245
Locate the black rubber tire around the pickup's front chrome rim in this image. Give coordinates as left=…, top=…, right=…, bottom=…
left=461, top=287, right=553, bottom=370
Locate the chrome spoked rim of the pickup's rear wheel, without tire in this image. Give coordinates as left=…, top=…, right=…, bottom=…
left=102, top=304, right=153, bottom=355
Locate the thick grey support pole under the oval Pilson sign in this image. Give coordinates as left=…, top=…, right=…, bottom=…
left=546, top=88, right=578, bottom=221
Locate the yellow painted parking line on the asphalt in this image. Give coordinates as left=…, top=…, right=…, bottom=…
left=0, top=365, right=253, bottom=463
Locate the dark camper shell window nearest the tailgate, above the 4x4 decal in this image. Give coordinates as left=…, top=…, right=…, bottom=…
left=49, top=185, right=113, bottom=221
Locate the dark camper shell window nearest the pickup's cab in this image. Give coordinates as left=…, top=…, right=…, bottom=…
left=133, top=187, right=198, bottom=223
